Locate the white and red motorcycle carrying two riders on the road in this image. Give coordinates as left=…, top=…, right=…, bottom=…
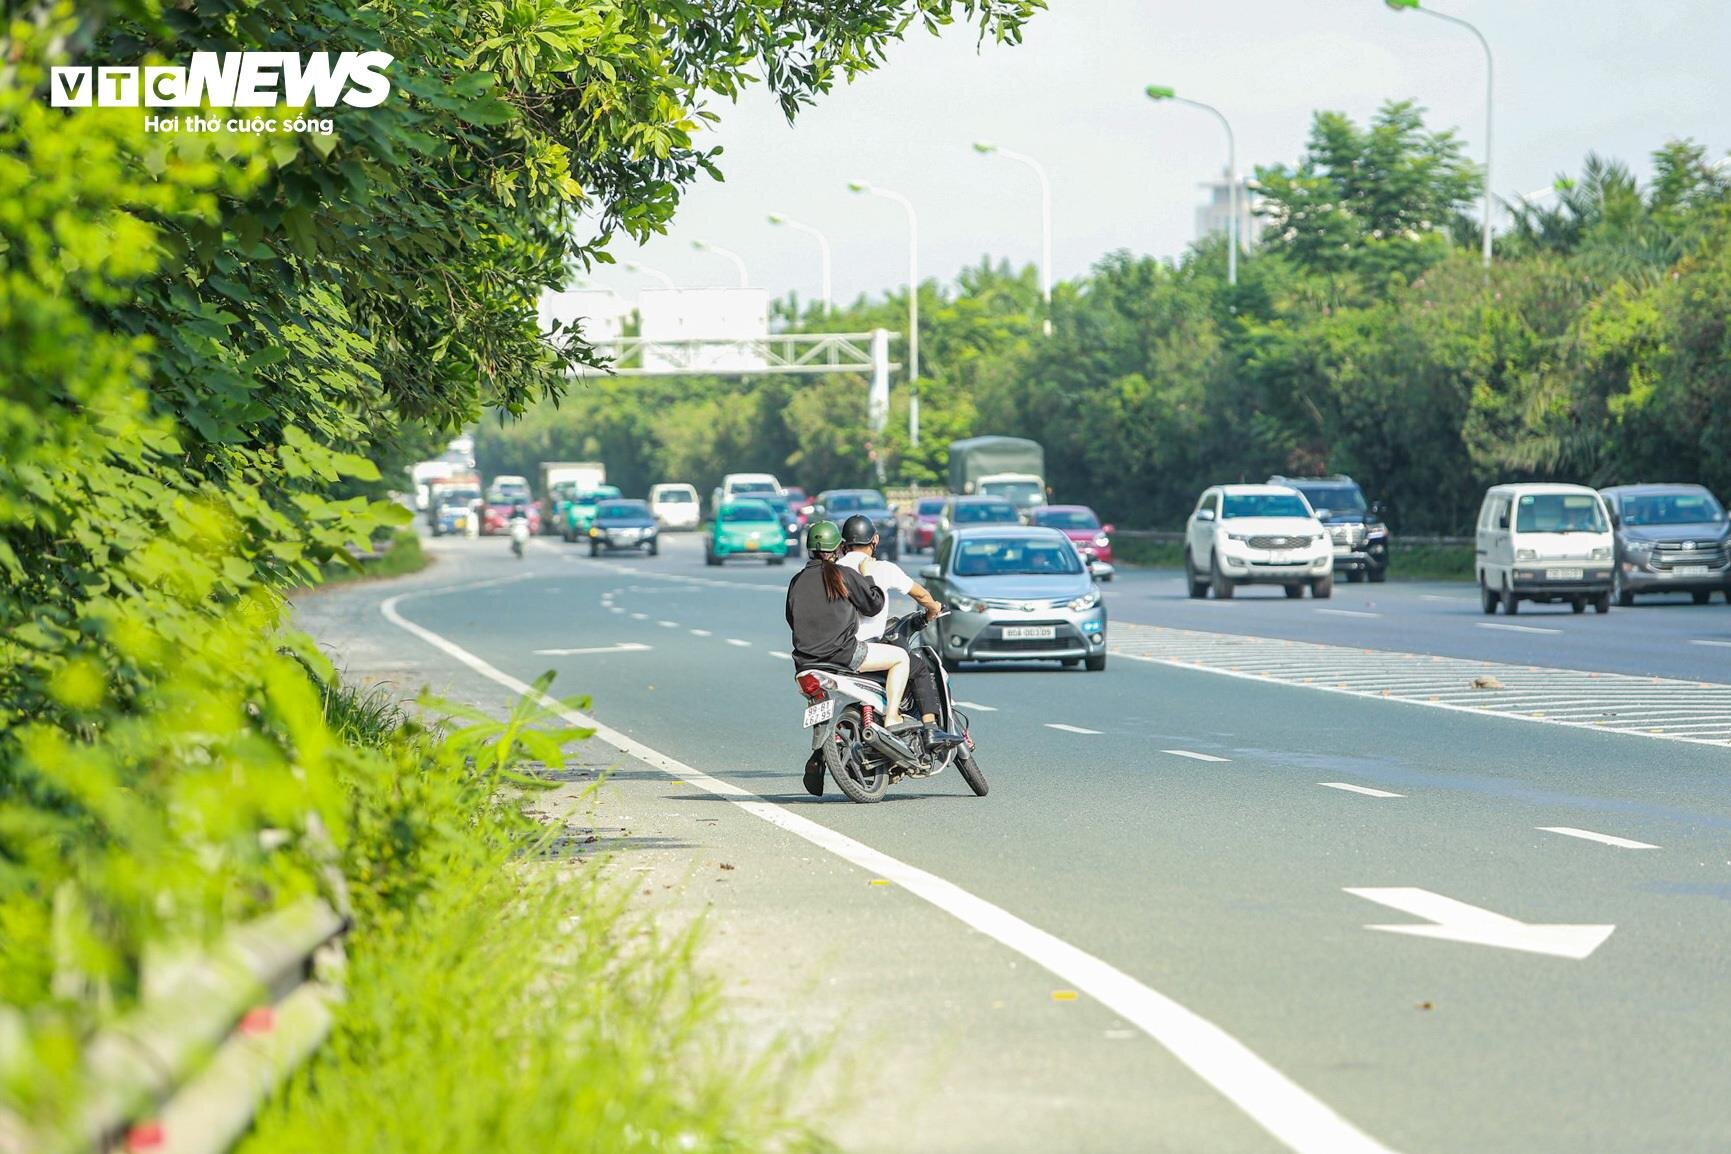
left=795, top=612, right=987, bottom=803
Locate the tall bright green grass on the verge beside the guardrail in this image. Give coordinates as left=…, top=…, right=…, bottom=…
left=239, top=687, right=831, bottom=1154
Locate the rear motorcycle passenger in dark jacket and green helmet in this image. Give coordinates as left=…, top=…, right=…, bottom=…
left=788, top=521, right=907, bottom=728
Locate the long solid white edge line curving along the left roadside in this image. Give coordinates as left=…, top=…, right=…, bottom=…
left=379, top=578, right=1395, bottom=1154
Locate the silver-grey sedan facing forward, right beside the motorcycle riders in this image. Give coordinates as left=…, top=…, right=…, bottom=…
left=919, top=524, right=1106, bottom=670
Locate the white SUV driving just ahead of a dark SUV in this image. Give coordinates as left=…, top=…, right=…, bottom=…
left=1184, top=484, right=1335, bottom=599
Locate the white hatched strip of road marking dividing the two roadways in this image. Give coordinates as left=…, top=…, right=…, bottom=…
left=1110, top=623, right=1731, bottom=747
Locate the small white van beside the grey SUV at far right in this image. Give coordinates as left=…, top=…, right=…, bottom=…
left=1475, top=484, right=1615, bottom=614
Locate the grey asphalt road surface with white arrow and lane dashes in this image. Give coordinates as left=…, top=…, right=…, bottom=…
left=304, top=536, right=1731, bottom=1154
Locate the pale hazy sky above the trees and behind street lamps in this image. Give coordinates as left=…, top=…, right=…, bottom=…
left=589, top=0, right=1731, bottom=311
